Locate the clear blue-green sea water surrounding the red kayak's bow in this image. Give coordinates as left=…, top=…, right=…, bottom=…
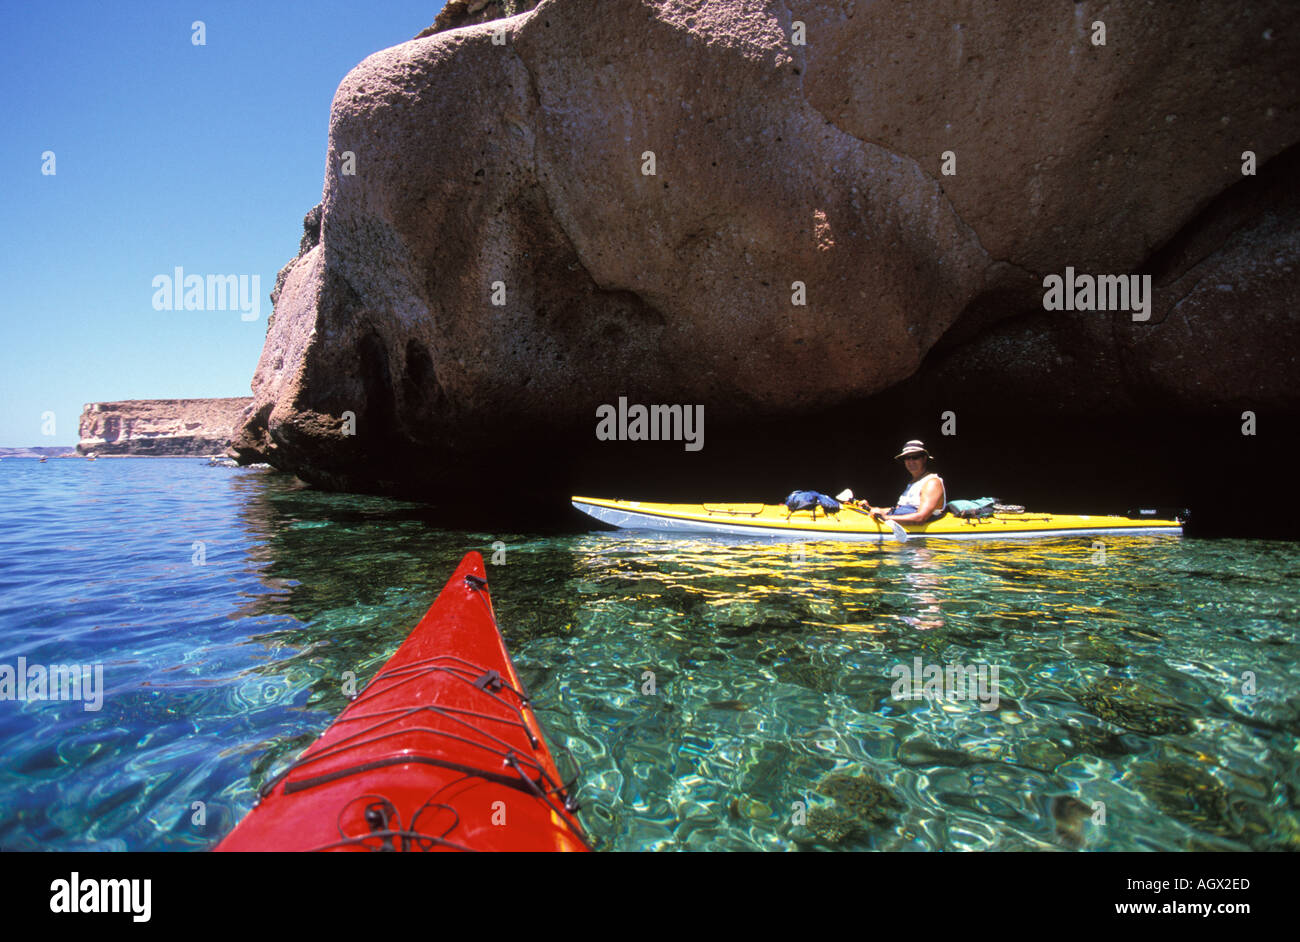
left=0, top=459, right=1300, bottom=850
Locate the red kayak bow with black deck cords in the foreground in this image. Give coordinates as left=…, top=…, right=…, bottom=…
left=216, top=552, right=590, bottom=851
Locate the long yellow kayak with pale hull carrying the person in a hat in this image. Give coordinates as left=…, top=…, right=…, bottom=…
left=572, top=498, right=1183, bottom=542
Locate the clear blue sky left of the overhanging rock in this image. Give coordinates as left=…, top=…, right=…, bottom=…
left=0, top=0, right=442, bottom=446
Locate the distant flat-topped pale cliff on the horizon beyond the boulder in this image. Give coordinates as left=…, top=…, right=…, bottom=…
left=77, top=396, right=252, bottom=456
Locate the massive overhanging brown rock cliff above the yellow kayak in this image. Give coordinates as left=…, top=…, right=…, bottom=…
left=235, top=0, right=1300, bottom=494
